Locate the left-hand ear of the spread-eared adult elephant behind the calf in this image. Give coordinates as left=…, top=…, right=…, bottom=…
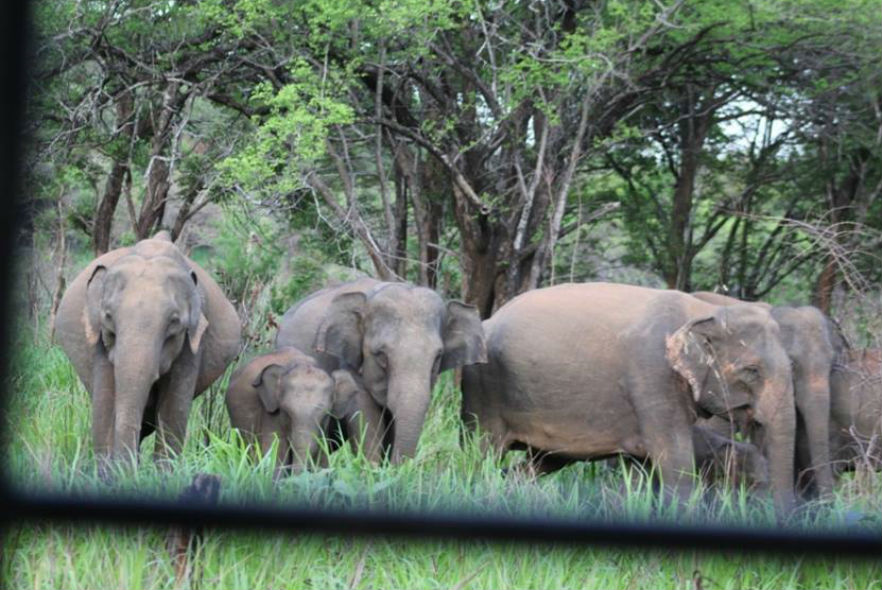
left=312, top=293, right=367, bottom=369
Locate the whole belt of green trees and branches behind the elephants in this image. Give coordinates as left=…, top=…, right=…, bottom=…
left=29, top=0, right=882, bottom=315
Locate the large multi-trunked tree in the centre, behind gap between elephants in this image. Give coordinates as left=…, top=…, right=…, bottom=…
left=218, top=2, right=748, bottom=316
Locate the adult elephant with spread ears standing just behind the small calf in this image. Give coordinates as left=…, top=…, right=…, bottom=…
left=276, top=279, right=487, bottom=463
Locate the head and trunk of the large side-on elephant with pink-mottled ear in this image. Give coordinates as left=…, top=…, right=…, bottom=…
left=667, top=305, right=796, bottom=510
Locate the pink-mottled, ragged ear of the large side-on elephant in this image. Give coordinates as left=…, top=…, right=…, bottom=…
left=665, top=316, right=717, bottom=403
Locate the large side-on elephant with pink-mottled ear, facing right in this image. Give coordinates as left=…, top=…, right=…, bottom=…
left=462, top=283, right=795, bottom=511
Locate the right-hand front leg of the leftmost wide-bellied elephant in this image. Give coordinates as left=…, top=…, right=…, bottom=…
left=154, top=347, right=199, bottom=464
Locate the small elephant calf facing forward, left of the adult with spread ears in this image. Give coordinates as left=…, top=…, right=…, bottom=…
left=225, top=348, right=382, bottom=476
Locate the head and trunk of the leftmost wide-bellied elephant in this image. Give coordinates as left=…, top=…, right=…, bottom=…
left=83, top=252, right=208, bottom=458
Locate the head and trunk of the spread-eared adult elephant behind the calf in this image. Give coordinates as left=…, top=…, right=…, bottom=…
left=313, top=283, right=487, bottom=462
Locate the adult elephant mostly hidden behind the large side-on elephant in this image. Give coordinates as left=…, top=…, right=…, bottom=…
left=693, top=292, right=844, bottom=497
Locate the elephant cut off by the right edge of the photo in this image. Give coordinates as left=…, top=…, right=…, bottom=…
left=824, top=348, right=882, bottom=473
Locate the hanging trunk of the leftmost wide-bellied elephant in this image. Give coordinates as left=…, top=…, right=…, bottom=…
left=113, top=337, right=159, bottom=468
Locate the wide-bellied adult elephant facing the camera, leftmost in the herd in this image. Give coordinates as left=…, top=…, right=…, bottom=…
left=55, top=232, right=241, bottom=473
